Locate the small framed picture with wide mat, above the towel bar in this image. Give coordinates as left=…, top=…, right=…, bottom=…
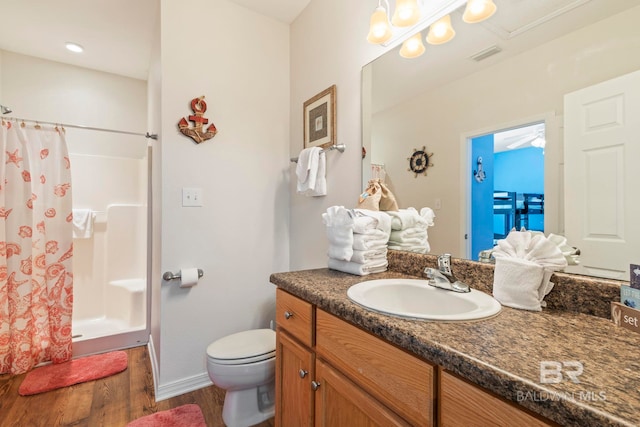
left=303, top=85, right=336, bottom=148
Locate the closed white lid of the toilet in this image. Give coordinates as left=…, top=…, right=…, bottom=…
left=207, top=329, right=276, bottom=362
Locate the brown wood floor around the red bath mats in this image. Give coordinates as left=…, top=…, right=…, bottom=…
left=0, top=347, right=273, bottom=427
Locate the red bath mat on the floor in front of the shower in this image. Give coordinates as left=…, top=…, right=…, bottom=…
left=18, top=351, right=127, bottom=396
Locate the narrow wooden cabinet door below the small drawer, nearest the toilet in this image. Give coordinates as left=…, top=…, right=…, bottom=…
left=275, top=330, right=315, bottom=427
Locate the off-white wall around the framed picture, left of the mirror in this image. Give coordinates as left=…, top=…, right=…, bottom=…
left=289, top=0, right=392, bottom=270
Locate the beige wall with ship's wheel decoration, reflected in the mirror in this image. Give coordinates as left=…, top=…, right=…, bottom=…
left=372, top=7, right=640, bottom=256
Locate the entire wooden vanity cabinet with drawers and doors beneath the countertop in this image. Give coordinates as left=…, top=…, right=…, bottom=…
left=275, top=289, right=557, bottom=427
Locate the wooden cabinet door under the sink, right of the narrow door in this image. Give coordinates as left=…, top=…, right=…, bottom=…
left=314, top=360, right=410, bottom=427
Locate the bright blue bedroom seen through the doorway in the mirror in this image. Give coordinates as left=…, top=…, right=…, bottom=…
left=471, top=122, right=545, bottom=260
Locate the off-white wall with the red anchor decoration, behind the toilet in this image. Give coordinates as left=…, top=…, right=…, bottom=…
left=157, top=0, right=290, bottom=398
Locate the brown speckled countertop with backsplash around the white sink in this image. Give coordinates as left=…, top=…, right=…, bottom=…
left=271, top=251, right=640, bottom=427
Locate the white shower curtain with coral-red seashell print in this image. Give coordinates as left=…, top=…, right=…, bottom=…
left=0, top=120, right=73, bottom=374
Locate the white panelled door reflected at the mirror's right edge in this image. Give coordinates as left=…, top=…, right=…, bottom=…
left=564, top=71, right=640, bottom=280
